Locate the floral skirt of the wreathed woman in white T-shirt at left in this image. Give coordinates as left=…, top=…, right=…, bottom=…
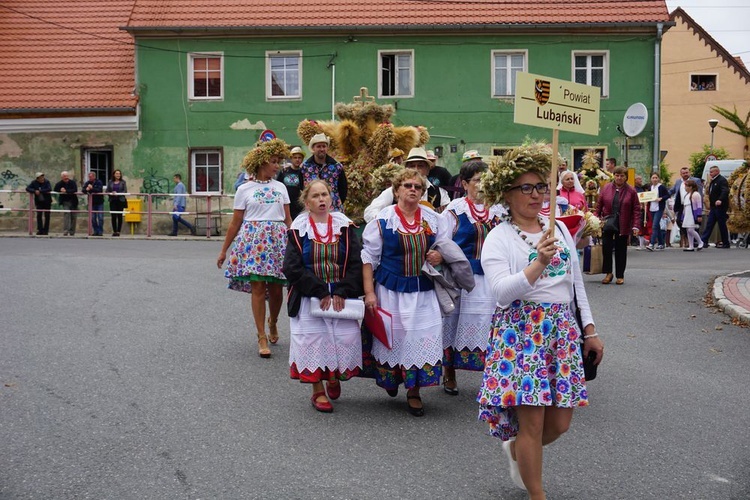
left=224, top=220, right=287, bottom=293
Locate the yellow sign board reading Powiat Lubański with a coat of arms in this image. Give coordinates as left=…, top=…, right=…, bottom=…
left=513, top=73, right=601, bottom=135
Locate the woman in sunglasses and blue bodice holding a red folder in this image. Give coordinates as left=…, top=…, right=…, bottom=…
left=362, top=168, right=450, bottom=417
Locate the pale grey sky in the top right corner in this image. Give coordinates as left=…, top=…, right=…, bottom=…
left=667, top=0, right=750, bottom=61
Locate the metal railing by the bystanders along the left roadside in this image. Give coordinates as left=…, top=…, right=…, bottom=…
left=0, top=190, right=234, bottom=238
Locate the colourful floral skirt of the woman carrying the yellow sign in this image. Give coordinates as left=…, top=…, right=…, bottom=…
left=477, top=300, right=588, bottom=441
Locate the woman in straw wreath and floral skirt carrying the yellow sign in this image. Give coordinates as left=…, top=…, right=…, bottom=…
left=477, top=145, right=603, bottom=499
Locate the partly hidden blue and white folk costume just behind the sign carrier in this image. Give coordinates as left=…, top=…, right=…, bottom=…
left=442, top=198, right=506, bottom=371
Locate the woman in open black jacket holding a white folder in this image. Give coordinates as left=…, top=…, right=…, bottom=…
left=283, top=180, right=362, bottom=413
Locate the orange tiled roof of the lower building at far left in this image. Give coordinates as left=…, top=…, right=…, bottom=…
left=0, top=0, right=137, bottom=112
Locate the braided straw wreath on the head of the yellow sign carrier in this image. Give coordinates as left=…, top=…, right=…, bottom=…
left=479, top=142, right=552, bottom=206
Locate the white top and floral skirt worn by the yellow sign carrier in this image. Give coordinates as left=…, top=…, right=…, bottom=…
left=477, top=221, right=592, bottom=441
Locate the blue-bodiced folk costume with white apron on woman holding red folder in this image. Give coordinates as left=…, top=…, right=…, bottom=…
left=362, top=205, right=448, bottom=390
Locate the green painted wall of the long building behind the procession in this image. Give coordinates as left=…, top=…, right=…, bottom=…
left=133, top=30, right=655, bottom=192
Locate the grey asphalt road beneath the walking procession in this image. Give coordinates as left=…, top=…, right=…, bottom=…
left=0, top=238, right=750, bottom=500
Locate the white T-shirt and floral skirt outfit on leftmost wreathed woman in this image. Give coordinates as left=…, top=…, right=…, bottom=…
left=224, top=180, right=289, bottom=293
